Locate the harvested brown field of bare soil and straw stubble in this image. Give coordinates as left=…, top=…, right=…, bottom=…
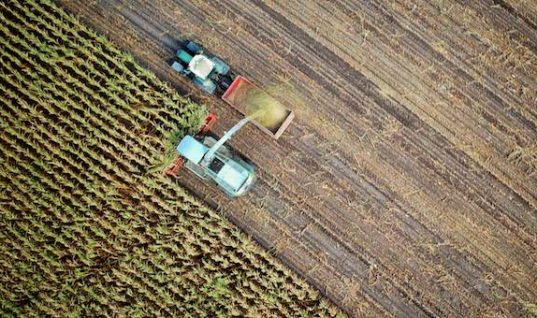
left=60, top=0, right=537, bottom=317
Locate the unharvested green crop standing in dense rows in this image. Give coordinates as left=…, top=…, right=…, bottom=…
left=0, top=0, right=338, bottom=317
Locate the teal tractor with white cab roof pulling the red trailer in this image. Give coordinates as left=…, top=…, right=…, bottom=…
left=171, top=40, right=234, bottom=94
